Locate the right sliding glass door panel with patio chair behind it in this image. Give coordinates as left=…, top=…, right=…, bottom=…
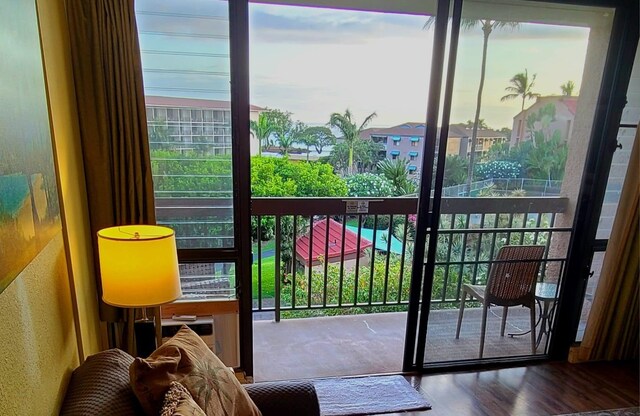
left=424, top=1, right=614, bottom=365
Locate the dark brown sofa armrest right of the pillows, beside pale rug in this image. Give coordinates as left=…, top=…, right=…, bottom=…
left=243, top=381, right=320, bottom=416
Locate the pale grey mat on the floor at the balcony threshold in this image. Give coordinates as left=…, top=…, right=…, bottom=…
left=313, top=376, right=431, bottom=416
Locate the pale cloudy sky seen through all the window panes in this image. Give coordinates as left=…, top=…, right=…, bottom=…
left=137, top=0, right=589, bottom=128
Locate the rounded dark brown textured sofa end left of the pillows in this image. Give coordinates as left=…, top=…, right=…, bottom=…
left=60, top=349, right=142, bottom=416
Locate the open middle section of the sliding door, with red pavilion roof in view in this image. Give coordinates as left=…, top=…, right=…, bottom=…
left=249, top=0, right=435, bottom=381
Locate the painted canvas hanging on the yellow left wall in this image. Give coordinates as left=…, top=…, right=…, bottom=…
left=0, top=0, right=60, bottom=292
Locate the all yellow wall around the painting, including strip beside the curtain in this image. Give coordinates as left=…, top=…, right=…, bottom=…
left=0, top=0, right=101, bottom=416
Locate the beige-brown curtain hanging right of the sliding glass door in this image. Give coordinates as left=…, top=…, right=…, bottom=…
left=571, top=126, right=640, bottom=361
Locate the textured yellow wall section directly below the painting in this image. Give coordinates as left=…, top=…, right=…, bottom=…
left=0, top=233, right=79, bottom=416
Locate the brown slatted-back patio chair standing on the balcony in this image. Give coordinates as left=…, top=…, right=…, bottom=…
left=456, top=246, right=544, bottom=358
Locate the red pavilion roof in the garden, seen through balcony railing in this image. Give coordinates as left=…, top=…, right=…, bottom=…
left=296, top=219, right=373, bottom=264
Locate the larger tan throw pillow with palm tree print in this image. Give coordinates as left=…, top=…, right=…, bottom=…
left=129, top=325, right=260, bottom=416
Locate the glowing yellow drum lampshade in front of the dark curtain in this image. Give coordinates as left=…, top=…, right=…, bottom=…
left=98, top=225, right=182, bottom=307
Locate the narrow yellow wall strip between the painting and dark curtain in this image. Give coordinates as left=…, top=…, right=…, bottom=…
left=37, top=0, right=104, bottom=360
